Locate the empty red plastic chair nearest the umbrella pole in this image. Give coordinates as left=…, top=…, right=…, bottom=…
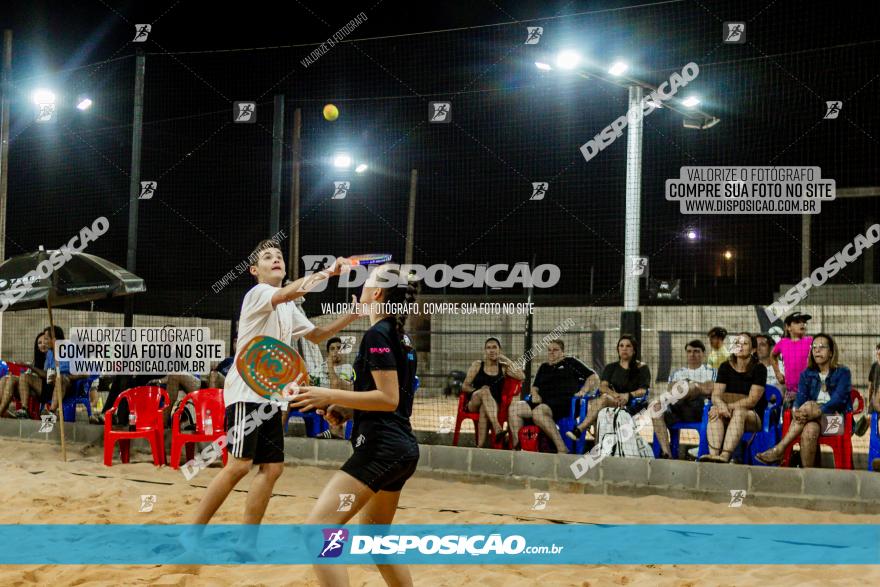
left=104, top=386, right=169, bottom=467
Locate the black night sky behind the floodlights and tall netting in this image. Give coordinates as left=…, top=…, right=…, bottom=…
left=0, top=0, right=880, bottom=318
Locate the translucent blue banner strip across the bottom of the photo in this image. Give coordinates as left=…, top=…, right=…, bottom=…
left=0, top=524, right=880, bottom=565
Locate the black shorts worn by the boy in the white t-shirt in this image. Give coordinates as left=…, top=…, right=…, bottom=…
left=226, top=402, right=284, bottom=465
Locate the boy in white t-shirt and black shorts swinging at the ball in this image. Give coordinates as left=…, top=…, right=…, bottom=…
left=192, top=240, right=359, bottom=539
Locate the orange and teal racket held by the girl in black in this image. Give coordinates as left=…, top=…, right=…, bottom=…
left=235, top=335, right=309, bottom=399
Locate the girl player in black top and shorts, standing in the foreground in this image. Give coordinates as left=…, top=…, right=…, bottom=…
left=292, top=265, right=419, bottom=586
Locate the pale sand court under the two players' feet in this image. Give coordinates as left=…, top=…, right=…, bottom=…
left=0, top=439, right=880, bottom=587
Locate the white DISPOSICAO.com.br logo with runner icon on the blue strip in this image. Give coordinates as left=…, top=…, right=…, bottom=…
left=318, top=528, right=565, bottom=558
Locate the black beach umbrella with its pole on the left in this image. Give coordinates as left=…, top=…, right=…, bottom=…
left=0, top=247, right=147, bottom=461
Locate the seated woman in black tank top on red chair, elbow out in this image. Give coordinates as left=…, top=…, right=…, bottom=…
left=461, top=337, right=525, bottom=447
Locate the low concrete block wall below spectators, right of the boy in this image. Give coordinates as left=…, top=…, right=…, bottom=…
left=285, top=437, right=880, bottom=513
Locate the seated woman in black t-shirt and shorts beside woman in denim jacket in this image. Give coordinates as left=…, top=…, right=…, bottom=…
left=700, top=332, right=767, bottom=463
